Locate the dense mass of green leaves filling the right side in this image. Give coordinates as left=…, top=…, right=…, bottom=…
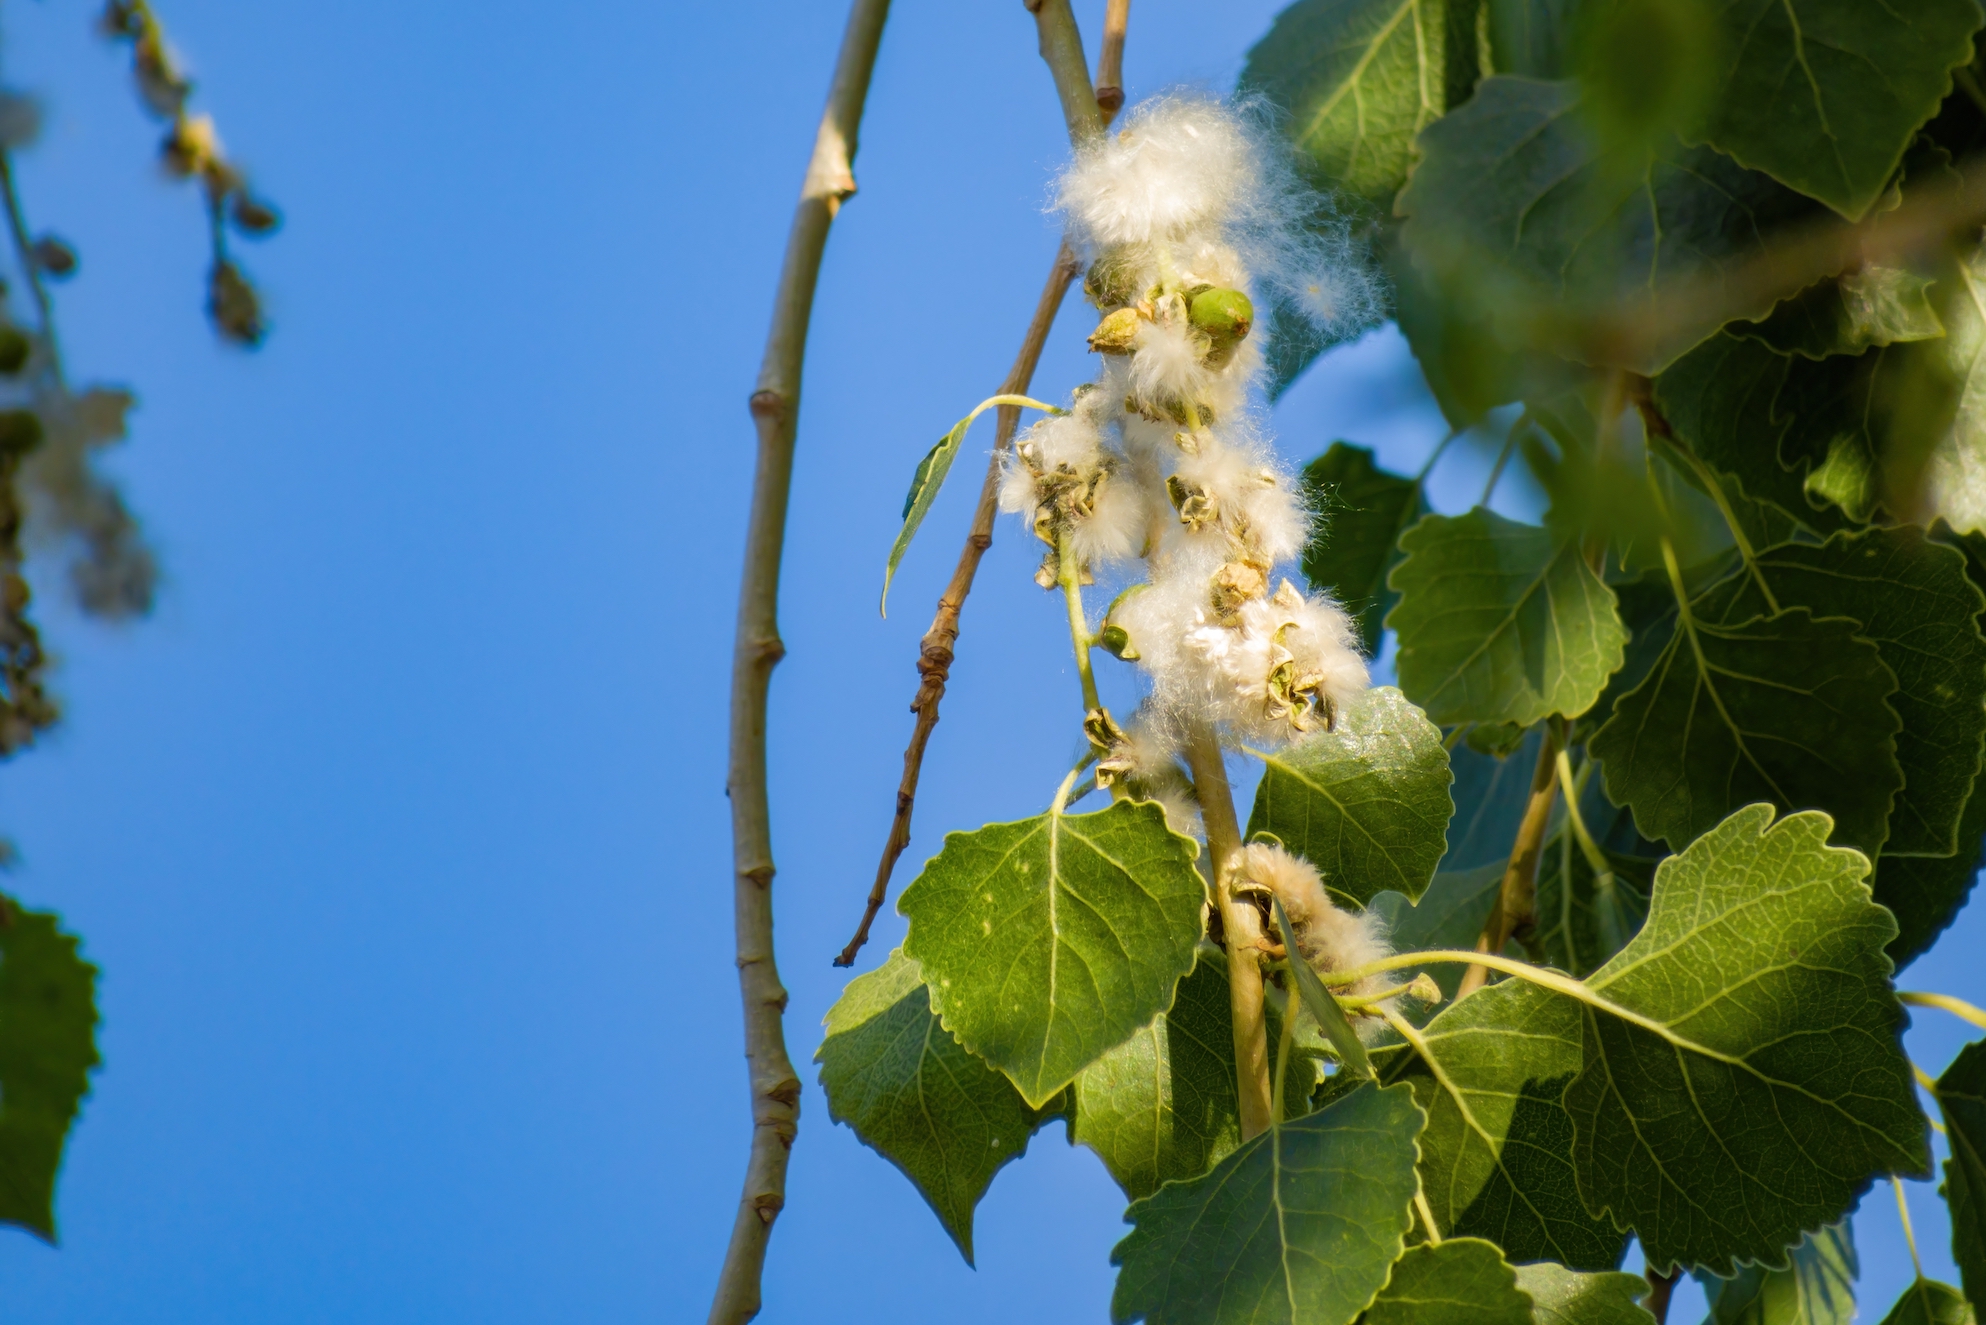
left=818, top=0, right=1986, bottom=1325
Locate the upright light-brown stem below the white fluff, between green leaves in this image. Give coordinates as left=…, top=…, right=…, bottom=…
left=1184, top=723, right=1273, bottom=1140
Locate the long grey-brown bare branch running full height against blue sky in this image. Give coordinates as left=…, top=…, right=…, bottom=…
left=709, top=0, right=890, bottom=1325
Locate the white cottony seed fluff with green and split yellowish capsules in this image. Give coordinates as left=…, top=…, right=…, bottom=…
left=1001, top=95, right=1374, bottom=746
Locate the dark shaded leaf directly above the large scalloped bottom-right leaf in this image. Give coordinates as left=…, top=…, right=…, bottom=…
left=1587, top=608, right=1903, bottom=856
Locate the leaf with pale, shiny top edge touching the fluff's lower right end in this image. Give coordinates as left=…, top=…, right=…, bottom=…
left=1247, top=685, right=1456, bottom=906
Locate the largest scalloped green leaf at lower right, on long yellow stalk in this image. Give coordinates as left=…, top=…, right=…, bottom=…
left=1565, top=805, right=1930, bottom=1275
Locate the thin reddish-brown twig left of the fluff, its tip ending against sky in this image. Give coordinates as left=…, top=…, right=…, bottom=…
left=834, top=244, right=1078, bottom=965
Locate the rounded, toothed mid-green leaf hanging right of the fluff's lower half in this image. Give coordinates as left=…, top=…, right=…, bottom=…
left=1386, top=507, right=1627, bottom=727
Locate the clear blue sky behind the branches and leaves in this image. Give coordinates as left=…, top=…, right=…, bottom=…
left=0, top=0, right=1986, bottom=1325
